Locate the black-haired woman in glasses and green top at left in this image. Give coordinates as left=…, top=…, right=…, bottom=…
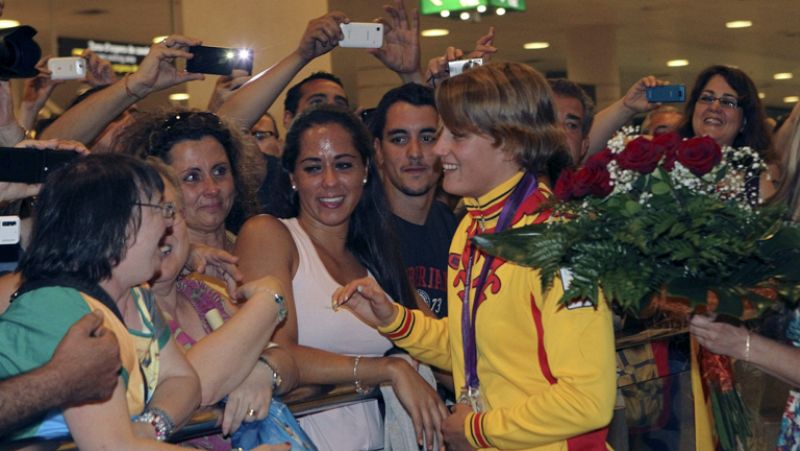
left=0, top=155, right=200, bottom=449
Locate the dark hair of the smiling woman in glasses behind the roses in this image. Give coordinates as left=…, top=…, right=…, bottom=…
left=678, top=66, right=772, bottom=161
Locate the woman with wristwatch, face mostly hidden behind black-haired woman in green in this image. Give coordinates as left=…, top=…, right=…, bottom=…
left=145, top=160, right=296, bottom=449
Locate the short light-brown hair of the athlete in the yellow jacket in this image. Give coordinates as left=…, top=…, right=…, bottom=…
left=436, top=63, right=571, bottom=178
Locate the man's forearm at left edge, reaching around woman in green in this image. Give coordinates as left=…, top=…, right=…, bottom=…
left=0, top=365, right=69, bottom=436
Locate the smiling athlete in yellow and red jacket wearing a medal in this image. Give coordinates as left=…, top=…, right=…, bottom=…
left=333, top=63, right=616, bottom=450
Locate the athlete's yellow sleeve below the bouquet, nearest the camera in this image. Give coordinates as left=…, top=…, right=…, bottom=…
left=465, top=280, right=616, bottom=449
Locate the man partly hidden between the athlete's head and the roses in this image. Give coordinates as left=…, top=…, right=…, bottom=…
left=547, top=78, right=594, bottom=166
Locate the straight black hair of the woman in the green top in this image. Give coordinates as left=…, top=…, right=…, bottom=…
left=19, top=154, right=164, bottom=284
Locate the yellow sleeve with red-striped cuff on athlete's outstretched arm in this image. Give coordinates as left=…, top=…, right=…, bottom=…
left=378, top=306, right=452, bottom=370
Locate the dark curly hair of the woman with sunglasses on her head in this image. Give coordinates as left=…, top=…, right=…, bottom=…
left=119, top=110, right=257, bottom=232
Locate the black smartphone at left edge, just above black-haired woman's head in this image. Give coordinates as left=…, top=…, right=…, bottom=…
left=0, top=147, right=79, bottom=184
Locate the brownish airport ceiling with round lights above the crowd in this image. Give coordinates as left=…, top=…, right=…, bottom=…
left=4, top=0, right=800, bottom=108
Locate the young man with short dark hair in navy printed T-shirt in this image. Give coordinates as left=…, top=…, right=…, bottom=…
left=371, top=83, right=456, bottom=318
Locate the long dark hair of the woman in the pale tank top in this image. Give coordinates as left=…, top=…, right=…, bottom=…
left=283, top=105, right=416, bottom=308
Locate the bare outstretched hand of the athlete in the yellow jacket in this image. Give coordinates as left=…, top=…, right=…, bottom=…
left=332, top=277, right=397, bottom=327
